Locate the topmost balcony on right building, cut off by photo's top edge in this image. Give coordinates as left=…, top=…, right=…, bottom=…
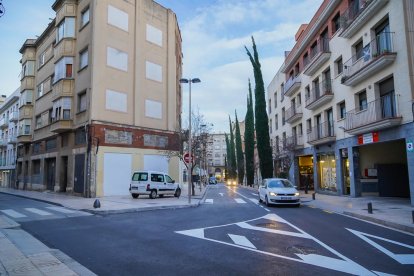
left=339, top=0, right=389, bottom=38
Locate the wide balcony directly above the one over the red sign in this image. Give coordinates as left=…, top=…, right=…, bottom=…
left=341, top=32, right=397, bottom=86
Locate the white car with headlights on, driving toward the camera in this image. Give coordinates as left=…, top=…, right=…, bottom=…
left=259, top=178, right=300, bottom=207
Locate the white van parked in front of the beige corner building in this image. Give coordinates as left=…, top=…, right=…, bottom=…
left=129, top=171, right=181, bottom=198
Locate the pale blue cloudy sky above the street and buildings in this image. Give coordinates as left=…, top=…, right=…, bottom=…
left=0, top=0, right=322, bottom=132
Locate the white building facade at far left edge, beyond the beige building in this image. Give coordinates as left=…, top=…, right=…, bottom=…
left=0, top=89, right=20, bottom=187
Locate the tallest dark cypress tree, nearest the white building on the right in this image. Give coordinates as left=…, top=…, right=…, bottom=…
left=245, top=36, right=273, bottom=178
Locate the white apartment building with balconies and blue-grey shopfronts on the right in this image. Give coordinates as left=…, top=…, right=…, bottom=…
left=267, top=0, right=414, bottom=205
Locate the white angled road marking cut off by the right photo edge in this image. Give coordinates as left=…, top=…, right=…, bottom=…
left=346, top=228, right=414, bottom=264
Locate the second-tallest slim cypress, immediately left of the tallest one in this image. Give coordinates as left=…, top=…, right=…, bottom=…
left=244, top=80, right=255, bottom=186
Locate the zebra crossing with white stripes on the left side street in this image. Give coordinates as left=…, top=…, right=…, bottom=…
left=0, top=206, right=91, bottom=221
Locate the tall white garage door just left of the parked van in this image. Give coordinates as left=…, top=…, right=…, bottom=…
left=103, top=153, right=132, bottom=196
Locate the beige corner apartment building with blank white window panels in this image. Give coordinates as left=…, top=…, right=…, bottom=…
left=17, top=0, right=182, bottom=197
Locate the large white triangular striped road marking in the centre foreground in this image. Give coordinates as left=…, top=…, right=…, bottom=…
left=176, top=214, right=375, bottom=275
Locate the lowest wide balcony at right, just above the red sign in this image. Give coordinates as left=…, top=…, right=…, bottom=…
left=345, top=92, right=402, bottom=135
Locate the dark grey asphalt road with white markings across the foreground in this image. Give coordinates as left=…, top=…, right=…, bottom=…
left=9, top=185, right=414, bottom=275
